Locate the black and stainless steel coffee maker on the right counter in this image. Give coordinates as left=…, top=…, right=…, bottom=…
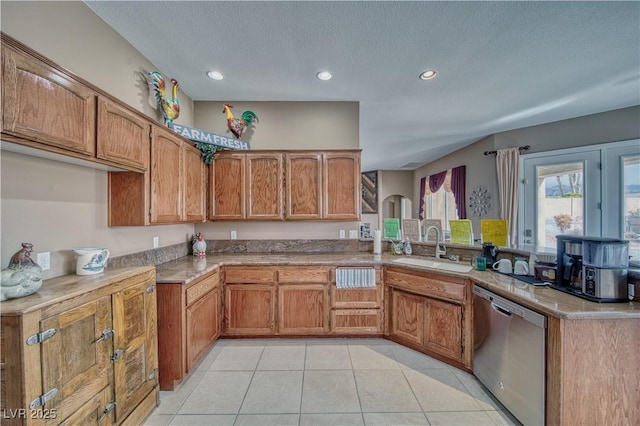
left=552, top=235, right=629, bottom=302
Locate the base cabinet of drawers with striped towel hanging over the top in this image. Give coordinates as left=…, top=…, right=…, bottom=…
left=330, top=266, right=383, bottom=335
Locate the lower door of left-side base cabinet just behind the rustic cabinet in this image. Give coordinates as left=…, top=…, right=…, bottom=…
left=187, top=287, right=220, bottom=373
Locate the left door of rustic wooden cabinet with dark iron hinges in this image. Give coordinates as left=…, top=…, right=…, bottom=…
left=41, top=296, right=113, bottom=424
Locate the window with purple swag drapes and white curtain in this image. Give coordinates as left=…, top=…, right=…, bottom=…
left=420, top=166, right=466, bottom=234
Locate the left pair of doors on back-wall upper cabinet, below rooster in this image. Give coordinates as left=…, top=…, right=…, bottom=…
left=209, top=152, right=284, bottom=220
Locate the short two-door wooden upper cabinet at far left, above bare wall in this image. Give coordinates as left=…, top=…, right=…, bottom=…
left=0, top=34, right=152, bottom=172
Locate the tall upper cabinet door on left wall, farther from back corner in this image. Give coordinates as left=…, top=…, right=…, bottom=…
left=150, top=126, right=183, bottom=223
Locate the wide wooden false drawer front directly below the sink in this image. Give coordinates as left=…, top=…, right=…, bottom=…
left=385, top=270, right=467, bottom=301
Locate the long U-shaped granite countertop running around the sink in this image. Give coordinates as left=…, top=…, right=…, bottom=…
left=156, top=252, right=640, bottom=319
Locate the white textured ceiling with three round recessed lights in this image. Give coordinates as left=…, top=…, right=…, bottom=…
left=86, top=1, right=640, bottom=170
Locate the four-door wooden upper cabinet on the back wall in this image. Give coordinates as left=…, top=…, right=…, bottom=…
left=209, top=151, right=360, bottom=221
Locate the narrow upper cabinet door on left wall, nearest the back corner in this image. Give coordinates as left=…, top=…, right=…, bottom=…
left=184, top=143, right=207, bottom=222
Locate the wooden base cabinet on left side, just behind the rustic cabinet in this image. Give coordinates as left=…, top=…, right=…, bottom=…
left=158, top=269, right=222, bottom=390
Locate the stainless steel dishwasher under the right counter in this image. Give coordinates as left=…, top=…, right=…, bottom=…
left=473, top=285, right=547, bottom=425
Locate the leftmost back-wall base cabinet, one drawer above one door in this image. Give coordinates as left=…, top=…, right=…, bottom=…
left=222, top=266, right=277, bottom=336
